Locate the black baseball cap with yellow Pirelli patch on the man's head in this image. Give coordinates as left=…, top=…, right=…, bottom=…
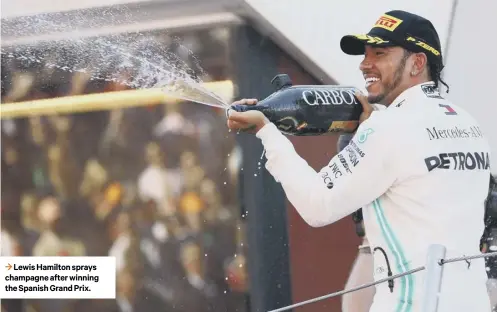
left=340, top=10, right=443, bottom=65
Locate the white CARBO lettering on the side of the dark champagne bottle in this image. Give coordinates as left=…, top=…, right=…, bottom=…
left=302, top=89, right=360, bottom=106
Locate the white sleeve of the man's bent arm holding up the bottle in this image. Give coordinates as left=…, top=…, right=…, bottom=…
left=257, top=113, right=395, bottom=227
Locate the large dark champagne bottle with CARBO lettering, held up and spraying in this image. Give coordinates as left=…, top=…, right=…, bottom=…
left=227, top=74, right=362, bottom=136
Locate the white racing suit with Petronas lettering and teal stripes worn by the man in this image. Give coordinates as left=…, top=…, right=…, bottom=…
left=257, top=82, right=490, bottom=312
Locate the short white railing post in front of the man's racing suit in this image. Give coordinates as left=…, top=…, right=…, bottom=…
left=422, top=245, right=446, bottom=312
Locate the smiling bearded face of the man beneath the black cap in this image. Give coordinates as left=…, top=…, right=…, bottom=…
left=359, top=46, right=409, bottom=105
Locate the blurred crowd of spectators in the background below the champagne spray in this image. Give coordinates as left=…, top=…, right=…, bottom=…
left=1, top=31, right=248, bottom=312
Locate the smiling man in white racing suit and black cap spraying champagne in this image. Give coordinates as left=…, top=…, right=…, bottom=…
left=228, top=11, right=490, bottom=312
